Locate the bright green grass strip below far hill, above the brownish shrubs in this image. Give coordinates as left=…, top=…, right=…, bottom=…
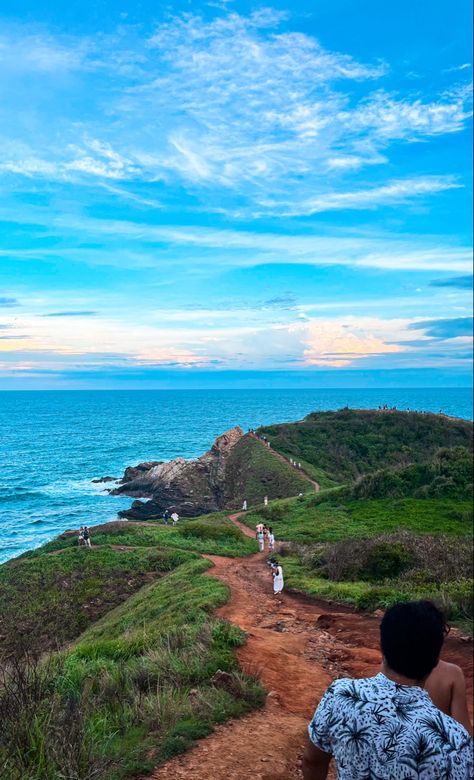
left=242, top=489, right=472, bottom=543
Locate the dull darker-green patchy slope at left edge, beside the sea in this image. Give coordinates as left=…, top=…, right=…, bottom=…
left=0, top=546, right=193, bottom=652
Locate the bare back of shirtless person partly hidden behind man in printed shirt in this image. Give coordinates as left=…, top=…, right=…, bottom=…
left=425, top=661, right=472, bottom=737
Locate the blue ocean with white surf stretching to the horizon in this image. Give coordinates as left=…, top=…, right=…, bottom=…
left=0, top=388, right=473, bottom=562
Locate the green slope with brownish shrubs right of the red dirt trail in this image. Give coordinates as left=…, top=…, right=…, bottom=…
left=244, top=488, right=473, bottom=625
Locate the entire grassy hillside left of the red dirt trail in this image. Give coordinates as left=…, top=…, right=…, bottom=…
left=0, top=516, right=264, bottom=780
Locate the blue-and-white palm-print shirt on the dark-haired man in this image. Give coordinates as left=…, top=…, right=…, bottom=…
left=308, top=674, right=474, bottom=780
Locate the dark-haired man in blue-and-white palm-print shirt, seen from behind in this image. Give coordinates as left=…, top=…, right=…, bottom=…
left=303, top=601, right=473, bottom=780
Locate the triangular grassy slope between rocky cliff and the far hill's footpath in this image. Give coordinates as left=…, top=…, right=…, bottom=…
left=225, top=436, right=312, bottom=509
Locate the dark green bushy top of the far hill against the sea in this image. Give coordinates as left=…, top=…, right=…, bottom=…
left=260, top=409, right=473, bottom=482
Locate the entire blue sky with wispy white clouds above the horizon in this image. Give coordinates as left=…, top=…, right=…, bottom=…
left=0, top=0, right=473, bottom=389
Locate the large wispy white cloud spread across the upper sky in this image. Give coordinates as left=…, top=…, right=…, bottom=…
left=0, top=9, right=470, bottom=216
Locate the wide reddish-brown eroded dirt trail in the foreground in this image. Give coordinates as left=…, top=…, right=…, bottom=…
left=146, top=514, right=472, bottom=780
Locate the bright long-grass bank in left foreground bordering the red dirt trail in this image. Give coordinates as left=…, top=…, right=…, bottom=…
left=0, top=556, right=264, bottom=780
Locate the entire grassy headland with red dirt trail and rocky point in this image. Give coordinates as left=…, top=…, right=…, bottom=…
left=0, top=409, right=473, bottom=780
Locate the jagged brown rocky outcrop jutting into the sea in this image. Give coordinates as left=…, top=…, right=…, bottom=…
left=111, top=427, right=244, bottom=519
